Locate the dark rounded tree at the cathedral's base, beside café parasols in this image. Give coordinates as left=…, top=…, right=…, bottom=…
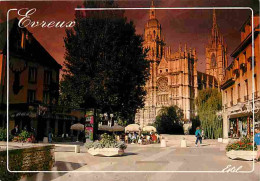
left=154, top=106, right=183, bottom=134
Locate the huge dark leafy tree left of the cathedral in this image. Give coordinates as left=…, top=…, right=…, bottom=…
left=61, top=1, right=149, bottom=123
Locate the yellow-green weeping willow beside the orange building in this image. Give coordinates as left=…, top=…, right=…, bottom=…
left=196, top=88, right=222, bottom=139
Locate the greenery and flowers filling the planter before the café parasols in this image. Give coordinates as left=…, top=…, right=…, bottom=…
left=85, top=133, right=127, bottom=150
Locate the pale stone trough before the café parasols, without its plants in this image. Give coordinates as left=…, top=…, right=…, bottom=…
left=88, top=148, right=124, bottom=156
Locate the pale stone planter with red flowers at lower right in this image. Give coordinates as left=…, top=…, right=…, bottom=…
left=226, top=137, right=257, bottom=160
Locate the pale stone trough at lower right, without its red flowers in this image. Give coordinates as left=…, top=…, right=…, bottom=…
left=226, top=150, right=256, bottom=161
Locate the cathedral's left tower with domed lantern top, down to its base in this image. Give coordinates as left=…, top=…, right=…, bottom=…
left=136, top=1, right=164, bottom=125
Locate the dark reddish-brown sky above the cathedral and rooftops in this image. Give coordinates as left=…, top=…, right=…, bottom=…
left=0, top=0, right=259, bottom=71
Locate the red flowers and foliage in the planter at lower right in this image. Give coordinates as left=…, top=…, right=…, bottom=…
left=226, top=137, right=257, bottom=151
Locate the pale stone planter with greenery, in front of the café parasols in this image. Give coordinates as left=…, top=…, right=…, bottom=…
left=85, top=133, right=127, bottom=156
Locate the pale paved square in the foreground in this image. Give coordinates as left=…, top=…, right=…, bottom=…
left=23, top=135, right=260, bottom=181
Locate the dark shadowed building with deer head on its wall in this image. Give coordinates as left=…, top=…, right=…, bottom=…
left=0, top=19, right=84, bottom=140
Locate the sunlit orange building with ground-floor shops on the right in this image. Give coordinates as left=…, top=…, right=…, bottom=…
left=221, top=15, right=260, bottom=138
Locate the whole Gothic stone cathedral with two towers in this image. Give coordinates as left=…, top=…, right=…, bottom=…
left=135, top=1, right=227, bottom=126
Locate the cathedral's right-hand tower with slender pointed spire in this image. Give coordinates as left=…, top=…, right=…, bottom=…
left=206, top=9, right=228, bottom=87
